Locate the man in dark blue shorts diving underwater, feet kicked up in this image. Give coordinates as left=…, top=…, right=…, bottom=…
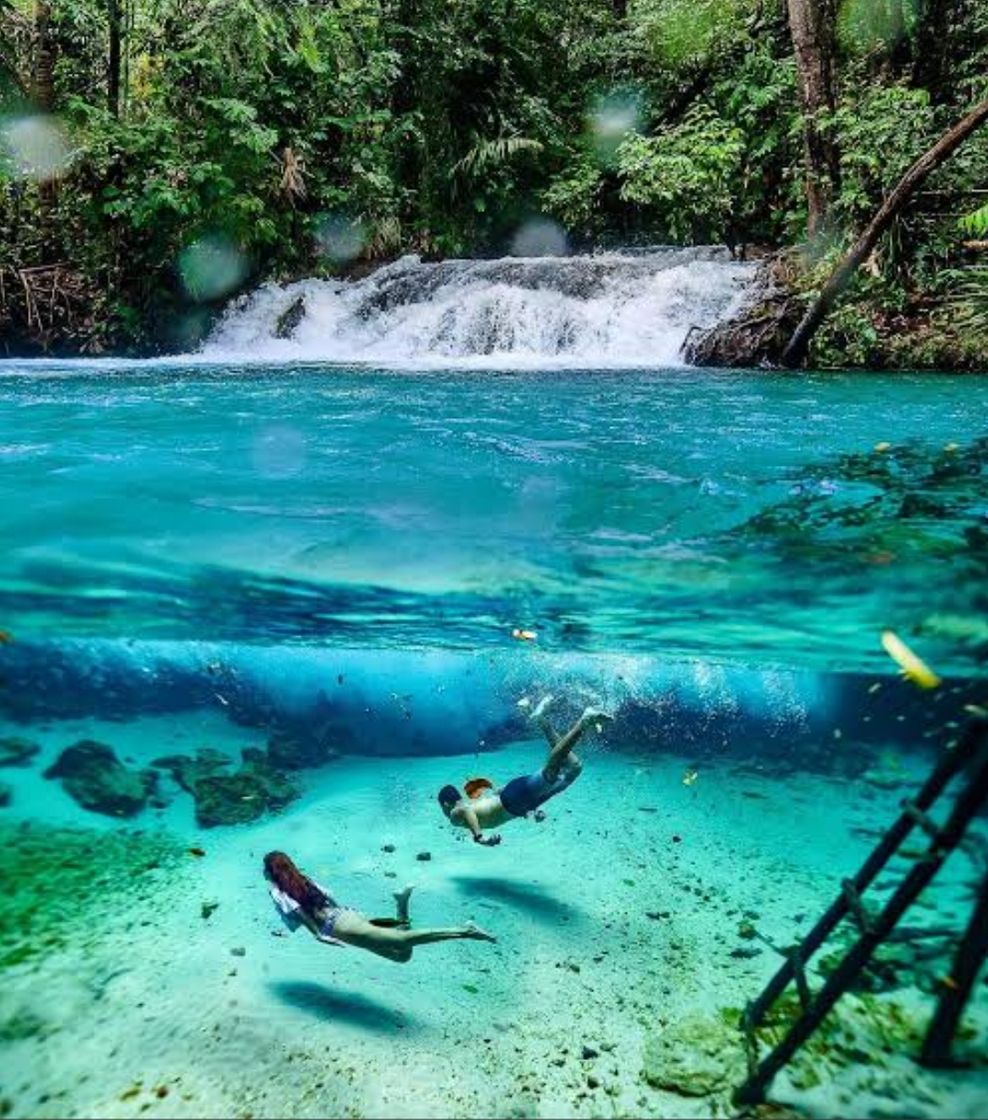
left=439, top=697, right=613, bottom=848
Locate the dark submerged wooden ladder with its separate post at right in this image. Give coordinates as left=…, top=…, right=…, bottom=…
left=734, top=708, right=988, bottom=1104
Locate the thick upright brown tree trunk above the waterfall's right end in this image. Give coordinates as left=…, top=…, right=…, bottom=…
left=789, top=0, right=840, bottom=237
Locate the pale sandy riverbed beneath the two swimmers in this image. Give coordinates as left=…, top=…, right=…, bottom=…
left=0, top=715, right=988, bottom=1117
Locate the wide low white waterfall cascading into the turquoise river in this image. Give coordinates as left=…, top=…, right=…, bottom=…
left=201, top=248, right=753, bottom=367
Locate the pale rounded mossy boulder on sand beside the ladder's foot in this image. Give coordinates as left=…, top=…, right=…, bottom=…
left=642, top=1016, right=745, bottom=1096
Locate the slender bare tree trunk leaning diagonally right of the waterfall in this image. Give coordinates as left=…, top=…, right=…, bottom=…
left=782, top=101, right=988, bottom=368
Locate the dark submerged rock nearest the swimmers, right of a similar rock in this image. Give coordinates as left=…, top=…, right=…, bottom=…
left=153, top=747, right=301, bottom=829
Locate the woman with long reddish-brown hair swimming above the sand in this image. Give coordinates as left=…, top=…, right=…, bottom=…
left=264, top=851, right=497, bottom=963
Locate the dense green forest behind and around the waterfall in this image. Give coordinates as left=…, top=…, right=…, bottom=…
left=0, top=0, right=988, bottom=363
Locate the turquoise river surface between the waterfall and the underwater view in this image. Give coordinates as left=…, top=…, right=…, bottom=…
left=0, top=364, right=988, bottom=674
